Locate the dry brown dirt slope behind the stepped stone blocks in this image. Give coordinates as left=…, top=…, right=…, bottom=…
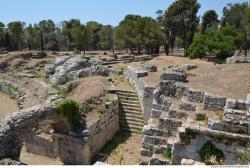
left=113, top=55, right=250, bottom=99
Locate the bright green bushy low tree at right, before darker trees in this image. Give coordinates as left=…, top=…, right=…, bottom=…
left=188, top=26, right=242, bottom=58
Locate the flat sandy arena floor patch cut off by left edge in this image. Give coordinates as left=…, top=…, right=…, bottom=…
left=0, top=92, right=18, bottom=118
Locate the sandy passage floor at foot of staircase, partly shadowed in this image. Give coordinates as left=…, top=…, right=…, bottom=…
left=94, top=132, right=142, bottom=165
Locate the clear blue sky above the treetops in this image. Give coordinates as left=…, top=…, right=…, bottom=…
left=0, top=0, right=250, bottom=26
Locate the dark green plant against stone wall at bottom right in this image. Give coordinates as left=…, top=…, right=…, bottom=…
left=199, top=141, right=225, bottom=165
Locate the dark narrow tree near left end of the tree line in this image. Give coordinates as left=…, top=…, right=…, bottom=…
left=8, top=21, right=25, bottom=50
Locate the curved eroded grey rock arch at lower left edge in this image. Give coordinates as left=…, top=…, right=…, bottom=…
left=0, top=105, right=56, bottom=160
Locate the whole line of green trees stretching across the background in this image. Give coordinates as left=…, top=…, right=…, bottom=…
left=0, top=0, right=250, bottom=58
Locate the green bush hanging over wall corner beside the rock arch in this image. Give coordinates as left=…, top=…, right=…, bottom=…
left=55, top=99, right=81, bottom=130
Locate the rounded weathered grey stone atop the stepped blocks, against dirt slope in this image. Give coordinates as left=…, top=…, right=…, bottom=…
left=160, top=68, right=187, bottom=82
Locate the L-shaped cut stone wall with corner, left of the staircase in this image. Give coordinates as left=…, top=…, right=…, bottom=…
left=22, top=101, right=119, bottom=165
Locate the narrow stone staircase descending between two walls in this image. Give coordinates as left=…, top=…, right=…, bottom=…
left=116, top=90, right=144, bottom=134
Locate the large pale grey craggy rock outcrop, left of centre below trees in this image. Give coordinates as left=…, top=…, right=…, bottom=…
left=45, top=56, right=109, bottom=85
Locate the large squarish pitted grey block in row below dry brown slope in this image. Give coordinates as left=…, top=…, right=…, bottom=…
left=203, top=94, right=227, bottom=111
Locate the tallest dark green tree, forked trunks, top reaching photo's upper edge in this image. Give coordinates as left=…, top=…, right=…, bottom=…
left=164, top=0, right=200, bottom=55
